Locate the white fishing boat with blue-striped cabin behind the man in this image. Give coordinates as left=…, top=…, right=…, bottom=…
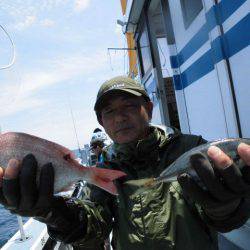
left=2, top=0, right=250, bottom=250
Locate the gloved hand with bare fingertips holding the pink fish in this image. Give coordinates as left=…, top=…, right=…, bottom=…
left=0, top=154, right=55, bottom=218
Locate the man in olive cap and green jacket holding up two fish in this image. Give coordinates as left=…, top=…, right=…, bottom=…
left=1, top=77, right=250, bottom=250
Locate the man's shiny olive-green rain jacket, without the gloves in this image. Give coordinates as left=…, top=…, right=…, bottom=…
left=50, top=127, right=218, bottom=250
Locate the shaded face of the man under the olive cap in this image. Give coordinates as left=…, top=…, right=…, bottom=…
left=101, top=93, right=153, bottom=144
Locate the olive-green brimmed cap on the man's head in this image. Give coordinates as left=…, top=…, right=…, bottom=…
left=94, top=76, right=150, bottom=111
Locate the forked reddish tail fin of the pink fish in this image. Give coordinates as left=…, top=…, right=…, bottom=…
left=91, top=167, right=126, bottom=195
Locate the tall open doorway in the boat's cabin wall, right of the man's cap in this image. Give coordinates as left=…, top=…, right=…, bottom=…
left=147, top=0, right=180, bottom=128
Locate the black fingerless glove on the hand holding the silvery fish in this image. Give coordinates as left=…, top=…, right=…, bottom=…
left=178, top=153, right=250, bottom=232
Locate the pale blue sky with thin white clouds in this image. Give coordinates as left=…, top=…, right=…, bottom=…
left=0, top=0, right=128, bottom=149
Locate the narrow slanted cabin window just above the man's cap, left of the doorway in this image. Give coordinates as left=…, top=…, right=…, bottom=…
left=138, top=22, right=152, bottom=77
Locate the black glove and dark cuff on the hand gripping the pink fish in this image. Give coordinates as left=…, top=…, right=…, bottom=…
left=0, top=154, right=87, bottom=241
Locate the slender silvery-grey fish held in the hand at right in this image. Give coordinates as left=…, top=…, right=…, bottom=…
left=125, top=138, right=250, bottom=188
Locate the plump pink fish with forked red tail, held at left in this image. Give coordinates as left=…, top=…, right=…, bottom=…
left=0, top=132, right=126, bottom=195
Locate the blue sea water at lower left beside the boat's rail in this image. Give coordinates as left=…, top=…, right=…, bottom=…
left=0, top=205, right=28, bottom=248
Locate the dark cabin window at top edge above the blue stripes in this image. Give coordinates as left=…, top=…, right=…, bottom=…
left=181, top=0, right=203, bottom=29
